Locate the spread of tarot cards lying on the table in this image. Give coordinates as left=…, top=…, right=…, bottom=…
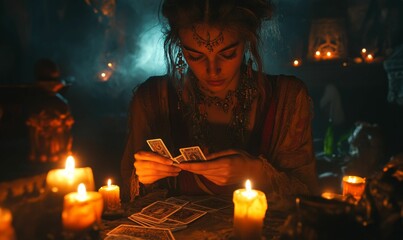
left=105, top=197, right=232, bottom=240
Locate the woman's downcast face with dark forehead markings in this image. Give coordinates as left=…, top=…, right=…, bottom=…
left=179, top=24, right=245, bottom=94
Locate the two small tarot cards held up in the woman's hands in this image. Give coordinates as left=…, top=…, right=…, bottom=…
left=147, top=138, right=206, bottom=163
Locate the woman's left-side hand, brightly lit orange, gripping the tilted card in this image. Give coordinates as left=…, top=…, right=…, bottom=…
left=134, top=151, right=181, bottom=184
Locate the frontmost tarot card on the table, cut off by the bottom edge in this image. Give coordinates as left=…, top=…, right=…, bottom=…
left=107, top=224, right=175, bottom=240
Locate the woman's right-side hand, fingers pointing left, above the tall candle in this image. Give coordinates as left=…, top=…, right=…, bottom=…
left=179, top=150, right=262, bottom=186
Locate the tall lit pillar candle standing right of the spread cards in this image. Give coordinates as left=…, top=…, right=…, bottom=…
left=233, top=180, right=267, bottom=239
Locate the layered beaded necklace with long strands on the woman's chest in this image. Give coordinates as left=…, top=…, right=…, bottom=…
left=178, top=69, right=258, bottom=148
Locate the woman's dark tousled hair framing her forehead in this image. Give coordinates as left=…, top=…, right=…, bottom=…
left=160, top=0, right=272, bottom=80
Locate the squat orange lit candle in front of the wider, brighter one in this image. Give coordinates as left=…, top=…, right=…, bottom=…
left=62, top=183, right=103, bottom=232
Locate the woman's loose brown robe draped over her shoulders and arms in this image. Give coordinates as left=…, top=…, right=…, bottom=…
left=121, top=75, right=316, bottom=201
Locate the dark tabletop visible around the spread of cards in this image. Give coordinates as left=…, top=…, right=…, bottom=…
left=100, top=192, right=287, bottom=240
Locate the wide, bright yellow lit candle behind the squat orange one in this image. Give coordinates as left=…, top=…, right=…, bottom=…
left=46, top=156, right=95, bottom=196
